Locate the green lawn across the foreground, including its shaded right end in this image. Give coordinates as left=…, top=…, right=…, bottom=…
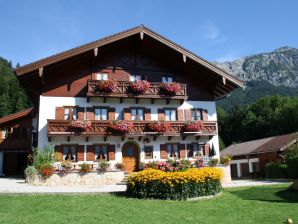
left=0, top=184, right=298, bottom=224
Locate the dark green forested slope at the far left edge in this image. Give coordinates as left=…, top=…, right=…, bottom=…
left=0, top=57, right=31, bottom=117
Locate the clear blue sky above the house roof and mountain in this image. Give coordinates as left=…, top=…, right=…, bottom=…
left=0, top=0, right=298, bottom=65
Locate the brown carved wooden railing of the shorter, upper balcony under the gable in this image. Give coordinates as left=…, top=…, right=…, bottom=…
left=87, top=80, right=187, bottom=100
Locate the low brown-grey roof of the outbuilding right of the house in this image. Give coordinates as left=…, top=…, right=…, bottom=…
left=220, top=132, right=298, bottom=156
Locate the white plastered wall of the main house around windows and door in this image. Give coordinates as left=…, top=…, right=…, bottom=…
left=38, top=96, right=219, bottom=163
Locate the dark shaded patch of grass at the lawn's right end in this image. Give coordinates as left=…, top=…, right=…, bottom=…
left=229, top=187, right=298, bottom=203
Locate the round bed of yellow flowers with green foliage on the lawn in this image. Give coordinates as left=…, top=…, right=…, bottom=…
left=127, top=167, right=223, bottom=200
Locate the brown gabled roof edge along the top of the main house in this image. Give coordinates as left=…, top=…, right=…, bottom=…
left=15, top=25, right=244, bottom=87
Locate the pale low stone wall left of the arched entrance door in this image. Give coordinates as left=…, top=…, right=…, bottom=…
left=26, top=171, right=124, bottom=186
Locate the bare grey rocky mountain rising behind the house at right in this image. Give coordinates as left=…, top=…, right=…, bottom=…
left=214, top=47, right=298, bottom=88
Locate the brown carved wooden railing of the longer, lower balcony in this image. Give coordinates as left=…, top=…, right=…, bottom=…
left=48, top=120, right=217, bottom=136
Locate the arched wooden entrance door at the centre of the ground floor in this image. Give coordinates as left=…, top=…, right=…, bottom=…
left=122, top=142, right=139, bottom=172
